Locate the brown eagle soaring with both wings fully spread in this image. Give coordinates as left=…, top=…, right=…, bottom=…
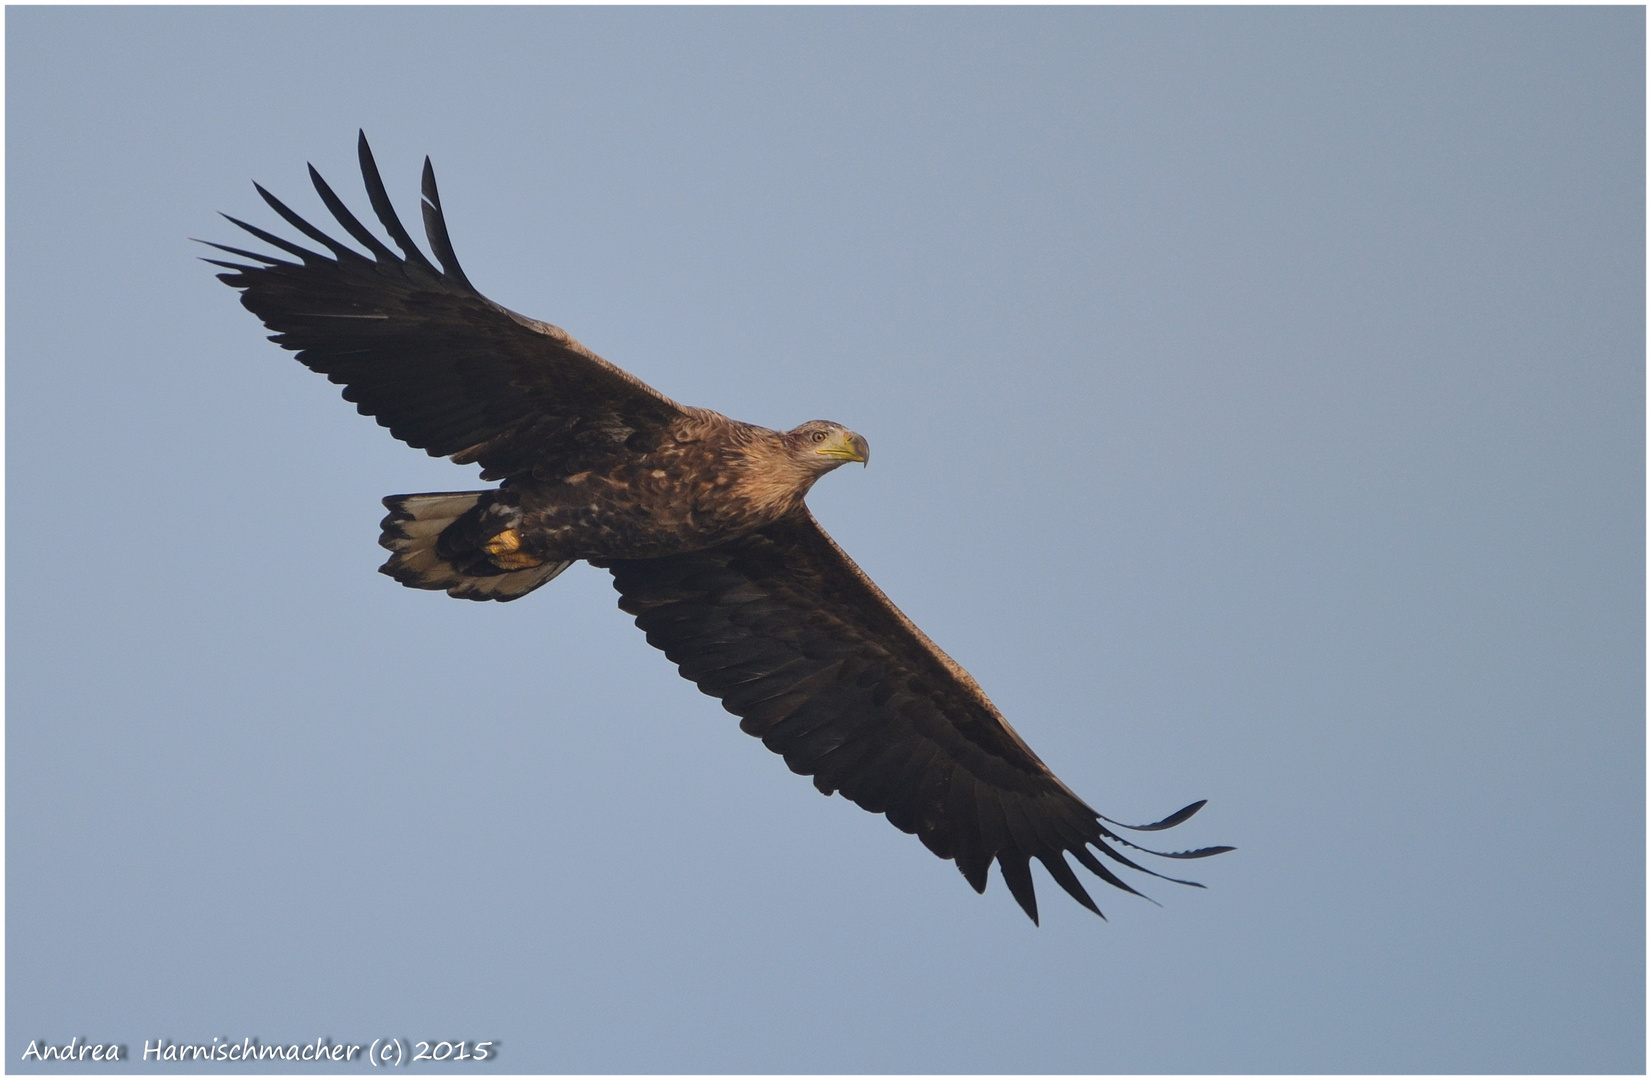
left=206, top=132, right=1232, bottom=923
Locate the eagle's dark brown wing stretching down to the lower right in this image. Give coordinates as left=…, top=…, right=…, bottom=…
left=599, top=510, right=1230, bottom=921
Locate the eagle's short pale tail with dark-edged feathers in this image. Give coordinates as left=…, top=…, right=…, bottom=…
left=378, top=490, right=573, bottom=599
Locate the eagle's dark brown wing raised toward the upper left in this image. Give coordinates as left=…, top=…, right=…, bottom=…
left=208, top=134, right=684, bottom=479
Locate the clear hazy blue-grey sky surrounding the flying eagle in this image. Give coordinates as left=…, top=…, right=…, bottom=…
left=5, top=8, right=1644, bottom=1072
